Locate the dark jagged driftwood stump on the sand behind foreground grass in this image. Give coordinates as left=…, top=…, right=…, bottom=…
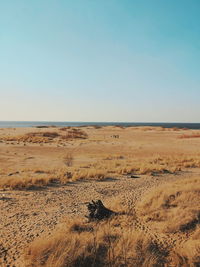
left=87, top=200, right=117, bottom=221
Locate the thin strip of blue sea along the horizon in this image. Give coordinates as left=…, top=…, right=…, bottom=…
left=0, top=121, right=200, bottom=129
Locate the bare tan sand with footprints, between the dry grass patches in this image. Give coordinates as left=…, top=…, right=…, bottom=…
left=0, top=127, right=200, bottom=267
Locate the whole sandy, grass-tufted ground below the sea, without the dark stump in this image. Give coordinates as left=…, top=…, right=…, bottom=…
left=0, top=126, right=200, bottom=267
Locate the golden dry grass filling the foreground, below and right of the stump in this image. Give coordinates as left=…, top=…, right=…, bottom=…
left=25, top=178, right=200, bottom=267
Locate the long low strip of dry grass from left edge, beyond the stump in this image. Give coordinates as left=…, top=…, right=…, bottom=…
left=0, top=167, right=110, bottom=190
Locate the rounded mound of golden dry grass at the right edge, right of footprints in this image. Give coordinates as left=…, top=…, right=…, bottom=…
left=138, top=177, right=200, bottom=266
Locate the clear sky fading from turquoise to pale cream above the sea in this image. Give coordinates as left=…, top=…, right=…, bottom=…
left=0, top=0, right=200, bottom=122
